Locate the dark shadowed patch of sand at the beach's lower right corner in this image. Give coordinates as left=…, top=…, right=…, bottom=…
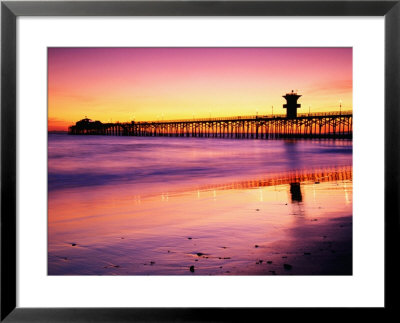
left=233, top=215, right=352, bottom=275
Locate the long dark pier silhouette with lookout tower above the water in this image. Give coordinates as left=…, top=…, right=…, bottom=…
left=68, top=91, right=353, bottom=139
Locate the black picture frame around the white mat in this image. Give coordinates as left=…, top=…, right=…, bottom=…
left=1, top=0, right=400, bottom=322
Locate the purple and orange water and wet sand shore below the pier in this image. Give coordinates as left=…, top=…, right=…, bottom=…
left=48, top=134, right=352, bottom=275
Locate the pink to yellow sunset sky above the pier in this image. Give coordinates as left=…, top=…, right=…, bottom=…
left=48, top=48, right=352, bottom=131
